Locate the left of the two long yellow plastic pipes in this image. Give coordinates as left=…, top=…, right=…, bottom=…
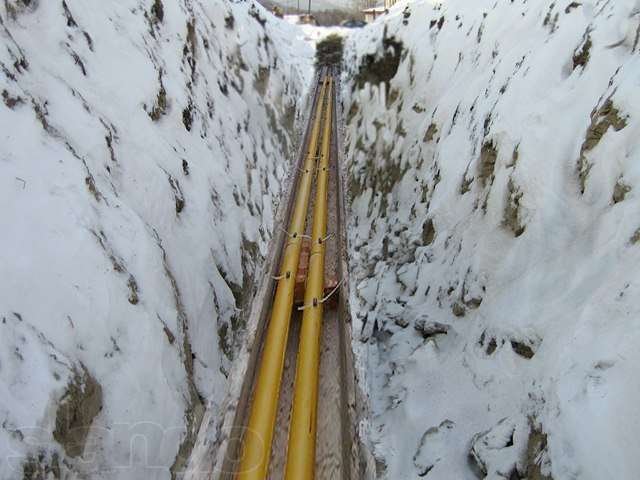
left=236, top=78, right=327, bottom=480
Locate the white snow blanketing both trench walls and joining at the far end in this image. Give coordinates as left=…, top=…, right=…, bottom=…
left=0, top=0, right=640, bottom=480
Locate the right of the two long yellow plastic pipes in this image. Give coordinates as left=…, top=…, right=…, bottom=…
left=285, top=80, right=333, bottom=480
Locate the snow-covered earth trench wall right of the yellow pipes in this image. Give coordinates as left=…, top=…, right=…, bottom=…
left=344, top=0, right=640, bottom=480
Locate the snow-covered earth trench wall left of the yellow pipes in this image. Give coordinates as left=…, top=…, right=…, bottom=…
left=0, top=0, right=313, bottom=479
